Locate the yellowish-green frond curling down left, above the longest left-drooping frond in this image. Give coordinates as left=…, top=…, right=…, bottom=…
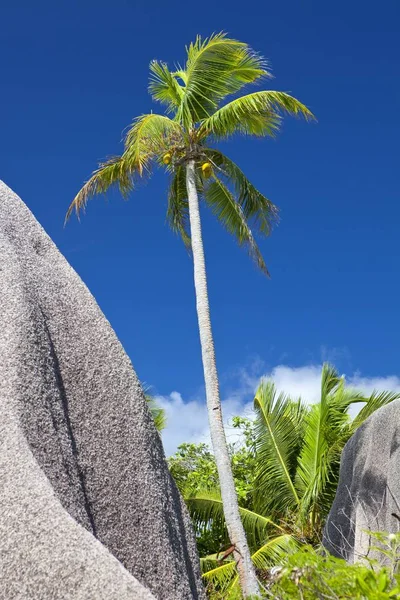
left=124, top=113, right=183, bottom=175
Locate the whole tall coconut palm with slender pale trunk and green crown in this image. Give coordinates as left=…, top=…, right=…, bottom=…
left=67, top=33, right=313, bottom=597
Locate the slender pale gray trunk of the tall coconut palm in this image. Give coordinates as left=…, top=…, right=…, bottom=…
left=186, top=160, right=259, bottom=598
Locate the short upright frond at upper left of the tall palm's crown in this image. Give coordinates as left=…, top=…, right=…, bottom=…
left=149, top=60, right=184, bottom=113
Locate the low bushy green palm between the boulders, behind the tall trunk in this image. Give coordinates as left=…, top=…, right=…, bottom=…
left=186, top=364, right=400, bottom=598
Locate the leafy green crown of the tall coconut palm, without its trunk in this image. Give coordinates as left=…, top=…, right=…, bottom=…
left=67, top=33, right=313, bottom=273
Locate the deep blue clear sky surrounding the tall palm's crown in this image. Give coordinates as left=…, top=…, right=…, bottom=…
left=0, top=0, right=400, bottom=450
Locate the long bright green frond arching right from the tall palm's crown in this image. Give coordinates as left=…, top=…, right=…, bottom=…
left=198, top=90, right=315, bottom=139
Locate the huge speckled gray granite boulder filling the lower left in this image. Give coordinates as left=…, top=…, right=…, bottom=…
left=0, top=182, right=205, bottom=600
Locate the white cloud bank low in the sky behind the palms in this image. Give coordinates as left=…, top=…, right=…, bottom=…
left=155, top=362, right=400, bottom=456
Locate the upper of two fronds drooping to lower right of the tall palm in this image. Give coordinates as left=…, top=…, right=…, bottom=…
left=204, top=149, right=278, bottom=235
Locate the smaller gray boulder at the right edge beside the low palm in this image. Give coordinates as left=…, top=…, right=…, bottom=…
left=323, top=400, right=400, bottom=562
